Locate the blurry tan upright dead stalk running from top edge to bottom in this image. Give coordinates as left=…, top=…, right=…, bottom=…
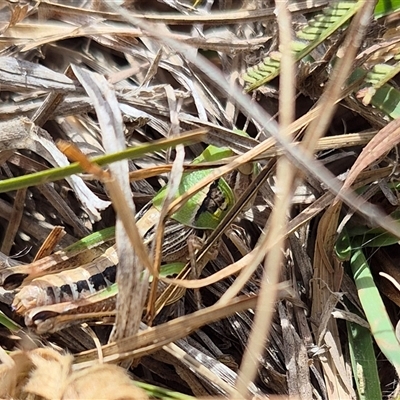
left=236, top=2, right=296, bottom=398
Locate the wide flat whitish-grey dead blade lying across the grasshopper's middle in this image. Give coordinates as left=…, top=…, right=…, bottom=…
left=68, top=67, right=149, bottom=339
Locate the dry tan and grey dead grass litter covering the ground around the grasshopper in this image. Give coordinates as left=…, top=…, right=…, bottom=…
left=0, top=0, right=399, bottom=399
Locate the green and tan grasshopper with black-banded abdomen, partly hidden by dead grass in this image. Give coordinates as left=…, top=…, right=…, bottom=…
left=0, top=131, right=256, bottom=332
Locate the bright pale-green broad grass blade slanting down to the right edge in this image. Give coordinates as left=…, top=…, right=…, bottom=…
left=350, top=250, right=400, bottom=374
